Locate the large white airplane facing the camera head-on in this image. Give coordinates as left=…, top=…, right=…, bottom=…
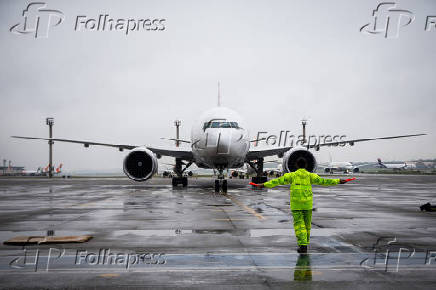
left=12, top=98, right=425, bottom=192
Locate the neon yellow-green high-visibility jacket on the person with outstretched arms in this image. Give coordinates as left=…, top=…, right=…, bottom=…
left=263, top=168, right=339, bottom=210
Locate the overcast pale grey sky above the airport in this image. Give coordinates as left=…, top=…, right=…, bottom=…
left=0, top=0, right=436, bottom=170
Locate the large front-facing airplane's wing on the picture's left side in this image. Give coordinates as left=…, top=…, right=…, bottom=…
left=11, top=136, right=194, bottom=160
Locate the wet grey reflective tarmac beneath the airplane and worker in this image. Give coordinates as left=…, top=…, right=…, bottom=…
left=0, top=175, right=436, bottom=289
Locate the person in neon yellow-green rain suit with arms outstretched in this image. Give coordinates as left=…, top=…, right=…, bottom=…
left=251, top=159, right=355, bottom=253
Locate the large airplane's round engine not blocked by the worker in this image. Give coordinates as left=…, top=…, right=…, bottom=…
left=123, top=147, right=158, bottom=181
